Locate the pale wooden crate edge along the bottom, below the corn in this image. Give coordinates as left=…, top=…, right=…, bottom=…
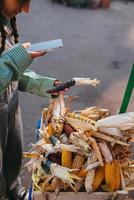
left=33, top=192, right=126, bottom=200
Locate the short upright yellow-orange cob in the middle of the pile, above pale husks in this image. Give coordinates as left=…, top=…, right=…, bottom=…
left=61, top=150, right=72, bottom=168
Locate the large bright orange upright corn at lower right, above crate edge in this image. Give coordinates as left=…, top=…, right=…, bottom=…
left=105, top=159, right=121, bottom=192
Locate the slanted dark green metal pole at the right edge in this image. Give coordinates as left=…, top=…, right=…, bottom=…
left=119, top=64, right=134, bottom=113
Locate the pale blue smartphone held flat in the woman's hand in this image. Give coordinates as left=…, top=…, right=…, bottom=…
left=27, top=39, right=63, bottom=52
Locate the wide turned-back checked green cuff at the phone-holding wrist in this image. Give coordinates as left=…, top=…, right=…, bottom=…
left=2, top=43, right=33, bottom=77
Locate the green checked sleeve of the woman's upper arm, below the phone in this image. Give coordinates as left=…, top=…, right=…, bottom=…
left=0, top=43, right=33, bottom=95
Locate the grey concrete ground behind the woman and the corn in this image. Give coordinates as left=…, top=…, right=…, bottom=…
left=18, top=0, right=134, bottom=191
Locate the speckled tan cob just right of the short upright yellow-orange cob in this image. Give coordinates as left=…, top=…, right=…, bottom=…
left=72, top=154, right=85, bottom=174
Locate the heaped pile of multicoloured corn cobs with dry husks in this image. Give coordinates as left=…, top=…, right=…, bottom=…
left=24, top=95, right=134, bottom=194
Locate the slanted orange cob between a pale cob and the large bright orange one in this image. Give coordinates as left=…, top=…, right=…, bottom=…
left=93, top=166, right=105, bottom=191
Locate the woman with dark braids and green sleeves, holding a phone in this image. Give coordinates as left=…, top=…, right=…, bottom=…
left=0, top=0, right=64, bottom=200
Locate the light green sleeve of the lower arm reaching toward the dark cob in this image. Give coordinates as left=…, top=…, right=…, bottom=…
left=19, top=70, right=56, bottom=98
